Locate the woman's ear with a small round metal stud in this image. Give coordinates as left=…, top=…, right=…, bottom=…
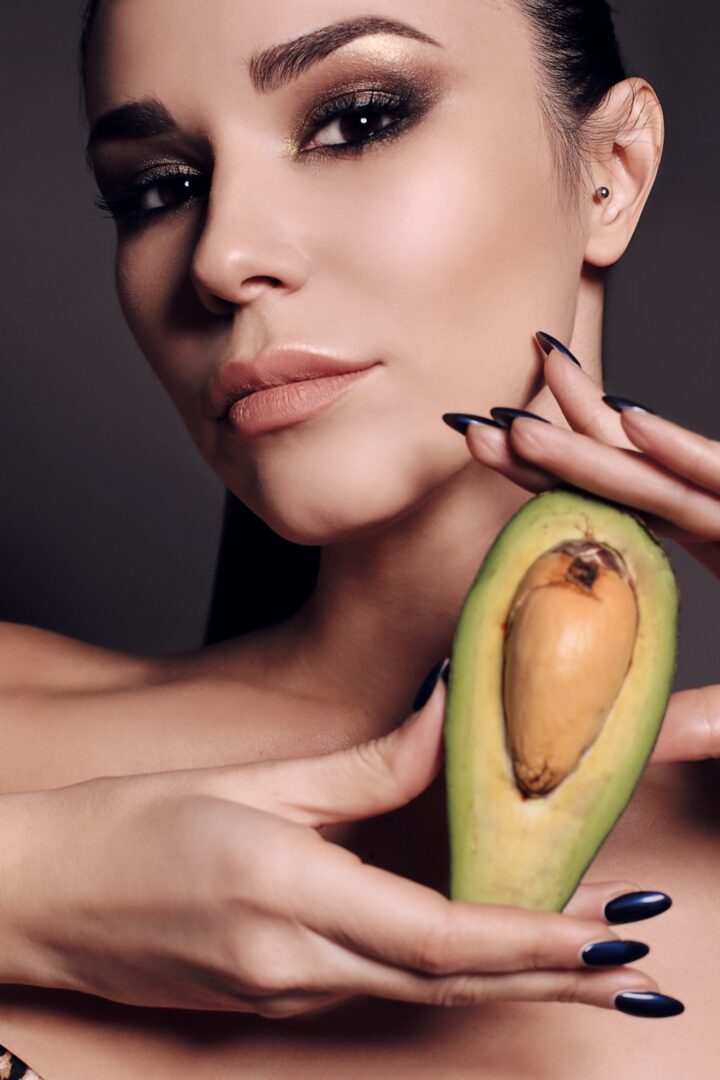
left=585, top=77, right=665, bottom=267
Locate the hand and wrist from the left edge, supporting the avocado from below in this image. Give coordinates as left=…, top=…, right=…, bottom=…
left=0, top=679, right=657, bottom=1017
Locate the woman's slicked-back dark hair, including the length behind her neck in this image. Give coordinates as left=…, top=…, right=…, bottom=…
left=80, top=0, right=627, bottom=642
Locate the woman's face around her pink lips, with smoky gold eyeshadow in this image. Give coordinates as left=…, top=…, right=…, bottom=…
left=89, top=0, right=585, bottom=543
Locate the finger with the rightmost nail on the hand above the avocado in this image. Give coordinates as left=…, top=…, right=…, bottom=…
left=620, top=408, right=720, bottom=494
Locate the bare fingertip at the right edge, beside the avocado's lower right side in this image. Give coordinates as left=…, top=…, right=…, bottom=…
left=648, top=686, right=720, bottom=765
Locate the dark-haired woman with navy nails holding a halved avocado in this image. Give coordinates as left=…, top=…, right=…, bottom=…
left=0, top=0, right=718, bottom=1080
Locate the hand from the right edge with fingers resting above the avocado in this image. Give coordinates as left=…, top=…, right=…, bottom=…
left=455, top=332, right=720, bottom=764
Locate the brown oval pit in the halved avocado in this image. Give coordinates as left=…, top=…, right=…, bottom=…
left=502, top=540, right=638, bottom=798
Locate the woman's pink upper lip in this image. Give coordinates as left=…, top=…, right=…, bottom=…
left=207, top=346, right=379, bottom=422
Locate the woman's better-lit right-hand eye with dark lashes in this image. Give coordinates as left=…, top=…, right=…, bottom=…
left=302, top=87, right=420, bottom=153
